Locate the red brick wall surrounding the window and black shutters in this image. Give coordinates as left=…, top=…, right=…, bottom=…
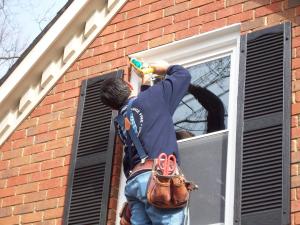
left=0, top=0, right=300, bottom=225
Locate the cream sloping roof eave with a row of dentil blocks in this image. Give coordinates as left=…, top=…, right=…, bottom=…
left=0, top=0, right=126, bottom=145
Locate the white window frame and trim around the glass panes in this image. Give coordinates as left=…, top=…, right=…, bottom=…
left=116, top=24, right=240, bottom=225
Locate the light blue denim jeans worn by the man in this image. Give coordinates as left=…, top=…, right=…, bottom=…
left=125, top=171, right=187, bottom=225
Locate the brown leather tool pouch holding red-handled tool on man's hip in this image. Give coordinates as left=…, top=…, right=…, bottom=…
left=147, top=164, right=197, bottom=209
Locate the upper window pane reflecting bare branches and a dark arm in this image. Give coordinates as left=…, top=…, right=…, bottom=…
left=173, top=56, right=230, bottom=139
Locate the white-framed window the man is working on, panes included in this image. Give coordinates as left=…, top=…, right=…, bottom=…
left=119, top=25, right=240, bottom=225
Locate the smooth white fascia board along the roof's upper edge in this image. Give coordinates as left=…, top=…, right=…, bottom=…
left=0, top=0, right=89, bottom=102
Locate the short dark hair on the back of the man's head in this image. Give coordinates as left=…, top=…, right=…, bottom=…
left=101, top=78, right=131, bottom=110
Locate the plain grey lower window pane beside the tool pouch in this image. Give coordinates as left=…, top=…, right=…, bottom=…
left=178, top=131, right=228, bottom=225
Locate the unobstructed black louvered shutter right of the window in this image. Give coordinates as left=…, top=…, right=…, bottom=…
left=235, top=22, right=291, bottom=225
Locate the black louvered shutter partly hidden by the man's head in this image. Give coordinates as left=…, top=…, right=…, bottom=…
left=64, top=71, right=123, bottom=225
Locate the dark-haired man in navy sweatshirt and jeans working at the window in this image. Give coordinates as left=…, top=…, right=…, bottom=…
left=101, top=60, right=191, bottom=225
